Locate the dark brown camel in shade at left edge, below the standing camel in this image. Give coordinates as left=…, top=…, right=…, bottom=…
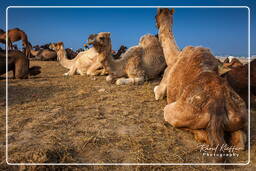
left=0, top=50, right=41, bottom=79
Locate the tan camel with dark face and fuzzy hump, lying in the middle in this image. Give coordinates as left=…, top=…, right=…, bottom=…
left=88, top=32, right=166, bottom=85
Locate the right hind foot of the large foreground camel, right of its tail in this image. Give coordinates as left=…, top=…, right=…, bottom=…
left=230, top=130, right=246, bottom=150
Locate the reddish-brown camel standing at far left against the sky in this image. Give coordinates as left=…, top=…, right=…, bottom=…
left=0, top=28, right=31, bottom=57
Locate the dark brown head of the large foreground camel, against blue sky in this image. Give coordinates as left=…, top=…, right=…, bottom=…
left=155, top=8, right=174, bottom=29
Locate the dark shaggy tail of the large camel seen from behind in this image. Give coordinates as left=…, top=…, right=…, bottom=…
left=206, top=99, right=227, bottom=163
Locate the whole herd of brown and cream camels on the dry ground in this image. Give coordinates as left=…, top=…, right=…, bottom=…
left=0, top=9, right=256, bottom=162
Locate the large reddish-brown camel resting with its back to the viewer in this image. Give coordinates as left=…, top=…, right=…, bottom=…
left=156, top=9, right=247, bottom=162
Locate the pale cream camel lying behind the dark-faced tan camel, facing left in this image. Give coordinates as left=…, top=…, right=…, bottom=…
left=50, top=42, right=105, bottom=75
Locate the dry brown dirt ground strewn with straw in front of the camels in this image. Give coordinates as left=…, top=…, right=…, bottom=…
left=0, top=61, right=256, bottom=171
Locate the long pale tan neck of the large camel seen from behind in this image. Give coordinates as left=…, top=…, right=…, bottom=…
left=158, top=25, right=180, bottom=66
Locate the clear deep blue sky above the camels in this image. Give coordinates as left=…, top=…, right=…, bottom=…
left=0, top=0, right=256, bottom=56
